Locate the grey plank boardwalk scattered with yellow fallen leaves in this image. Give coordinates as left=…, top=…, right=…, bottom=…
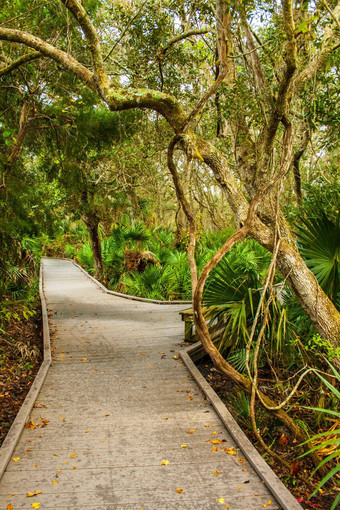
left=0, top=260, right=286, bottom=510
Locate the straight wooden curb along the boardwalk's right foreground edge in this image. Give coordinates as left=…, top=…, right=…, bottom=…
left=179, top=342, right=302, bottom=510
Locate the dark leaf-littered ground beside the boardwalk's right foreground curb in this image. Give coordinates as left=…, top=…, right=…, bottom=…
left=197, top=358, right=337, bottom=510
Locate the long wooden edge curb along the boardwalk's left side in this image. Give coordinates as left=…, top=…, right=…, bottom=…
left=0, top=263, right=51, bottom=479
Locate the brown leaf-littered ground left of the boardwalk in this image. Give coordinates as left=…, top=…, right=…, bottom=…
left=0, top=307, right=42, bottom=445
